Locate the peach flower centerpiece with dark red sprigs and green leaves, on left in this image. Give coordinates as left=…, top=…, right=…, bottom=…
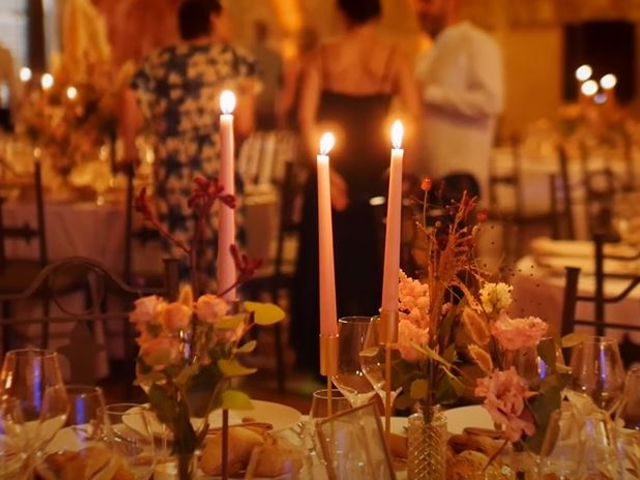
left=130, top=178, right=284, bottom=480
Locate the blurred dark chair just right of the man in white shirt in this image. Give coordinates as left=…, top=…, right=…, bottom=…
left=489, top=136, right=575, bottom=257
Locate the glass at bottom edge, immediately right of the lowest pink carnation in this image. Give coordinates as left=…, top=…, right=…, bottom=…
left=539, top=404, right=584, bottom=480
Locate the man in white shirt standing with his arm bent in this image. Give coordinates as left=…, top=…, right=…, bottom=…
left=414, top=0, right=503, bottom=199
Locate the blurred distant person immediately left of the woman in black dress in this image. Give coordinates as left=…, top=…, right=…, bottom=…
left=276, top=27, right=318, bottom=130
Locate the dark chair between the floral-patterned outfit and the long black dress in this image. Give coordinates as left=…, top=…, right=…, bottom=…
left=243, top=161, right=304, bottom=392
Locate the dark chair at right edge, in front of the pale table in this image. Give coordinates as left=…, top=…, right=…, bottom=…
left=561, top=234, right=640, bottom=365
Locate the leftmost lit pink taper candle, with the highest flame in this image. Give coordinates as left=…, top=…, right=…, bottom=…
left=217, top=90, right=236, bottom=301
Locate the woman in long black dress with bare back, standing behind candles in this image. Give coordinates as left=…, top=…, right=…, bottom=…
left=291, top=0, right=420, bottom=373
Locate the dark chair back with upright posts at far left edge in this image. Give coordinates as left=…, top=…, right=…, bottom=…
left=0, top=162, right=49, bottom=269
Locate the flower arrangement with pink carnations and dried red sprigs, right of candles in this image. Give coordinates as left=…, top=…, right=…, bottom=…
left=393, top=181, right=575, bottom=451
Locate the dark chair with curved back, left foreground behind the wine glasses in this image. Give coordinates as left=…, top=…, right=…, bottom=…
left=0, top=257, right=178, bottom=384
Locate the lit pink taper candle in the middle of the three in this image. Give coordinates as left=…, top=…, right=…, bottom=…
left=317, top=133, right=338, bottom=337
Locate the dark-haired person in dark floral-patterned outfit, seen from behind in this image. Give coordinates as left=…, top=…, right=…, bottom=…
left=122, top=0, right=255, bottom=279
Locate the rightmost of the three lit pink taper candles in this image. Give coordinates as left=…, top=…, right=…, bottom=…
left=381, top=120, right=404, bottom=338
